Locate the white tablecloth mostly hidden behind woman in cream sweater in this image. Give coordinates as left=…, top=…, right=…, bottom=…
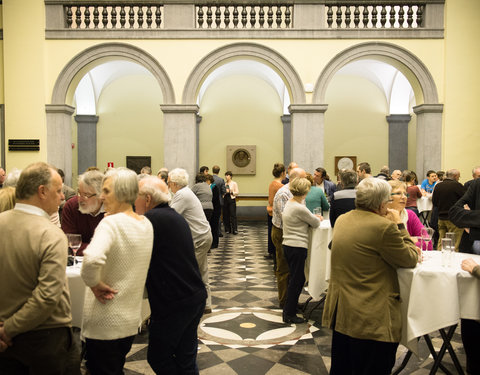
left=67, top=264, right=150, bottom=328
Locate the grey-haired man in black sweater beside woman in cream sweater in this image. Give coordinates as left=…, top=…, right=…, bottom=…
left=135, top=177, right=207, bottom=374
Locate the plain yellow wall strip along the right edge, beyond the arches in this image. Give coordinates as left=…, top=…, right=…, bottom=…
left=442, top=0, right=480, bottom=181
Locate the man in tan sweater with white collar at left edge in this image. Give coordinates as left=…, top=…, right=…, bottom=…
left=0, top=163, right=79, bottom=374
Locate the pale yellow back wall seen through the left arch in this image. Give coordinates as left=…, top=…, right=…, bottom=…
left=97, top=75, right=163, bottom=172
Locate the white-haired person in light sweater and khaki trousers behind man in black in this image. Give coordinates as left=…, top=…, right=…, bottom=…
left=168, top=168, right=212, bottom=313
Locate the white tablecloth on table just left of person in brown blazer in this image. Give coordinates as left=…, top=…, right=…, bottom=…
left=308, top=220, right=332, bottom=300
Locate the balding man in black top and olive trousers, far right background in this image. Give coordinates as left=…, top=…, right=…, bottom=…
left=432, top=169, right=466, bottom=251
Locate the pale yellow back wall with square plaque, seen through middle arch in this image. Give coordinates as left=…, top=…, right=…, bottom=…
left=199, top=75, right=283, bottom=200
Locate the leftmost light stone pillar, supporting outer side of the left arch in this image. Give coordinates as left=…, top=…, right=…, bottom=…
left=45, top=104, right=75, bottom=186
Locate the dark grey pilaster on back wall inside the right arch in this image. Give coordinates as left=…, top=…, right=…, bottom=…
left=387, top=114, right=412, bottom=172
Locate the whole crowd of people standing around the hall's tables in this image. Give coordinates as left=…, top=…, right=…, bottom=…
left=0, top=162, right=480, bottom=374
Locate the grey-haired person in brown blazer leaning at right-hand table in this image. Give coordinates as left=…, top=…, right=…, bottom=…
left=322, top=178, right=420, bottom=375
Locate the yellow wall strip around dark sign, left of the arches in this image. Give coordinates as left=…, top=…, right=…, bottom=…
left=3, top=1, right=47, bottom=169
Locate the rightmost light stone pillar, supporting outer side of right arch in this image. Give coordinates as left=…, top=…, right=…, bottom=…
left=413, top=104, right=443, bottom=180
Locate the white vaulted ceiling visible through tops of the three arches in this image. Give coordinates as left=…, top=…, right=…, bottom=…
left=75, top=60, right=414, bottom=115
